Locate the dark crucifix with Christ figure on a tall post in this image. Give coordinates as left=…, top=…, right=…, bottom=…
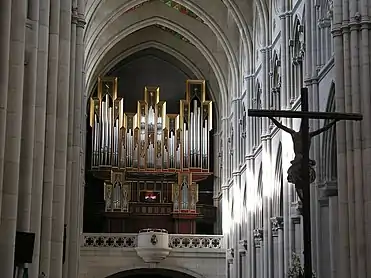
left=248, top=88, right=362, bottom=278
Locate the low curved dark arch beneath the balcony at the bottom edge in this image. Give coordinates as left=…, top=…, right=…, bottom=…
left=106, top=267, right=204, bottom=278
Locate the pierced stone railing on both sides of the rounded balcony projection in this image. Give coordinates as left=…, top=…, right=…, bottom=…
left=81, top=233, right=223, bottom=249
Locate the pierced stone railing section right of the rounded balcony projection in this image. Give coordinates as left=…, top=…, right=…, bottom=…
left=169, top=234, right=223, bottom=249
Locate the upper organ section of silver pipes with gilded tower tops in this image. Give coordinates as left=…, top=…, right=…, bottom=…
left=90, top=77, right=212, bottom=172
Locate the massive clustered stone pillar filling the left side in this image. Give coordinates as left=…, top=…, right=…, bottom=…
left=0, top=0, right=86, bottom=278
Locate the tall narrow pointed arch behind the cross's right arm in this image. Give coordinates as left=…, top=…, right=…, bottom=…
left=322, top=83, right=337, bottom=183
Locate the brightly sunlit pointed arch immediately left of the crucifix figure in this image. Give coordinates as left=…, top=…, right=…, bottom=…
left=272, top=142, right=283, bottom=216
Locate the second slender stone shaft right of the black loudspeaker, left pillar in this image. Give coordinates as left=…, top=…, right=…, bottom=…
left=40, top=0, right=62, bottom=277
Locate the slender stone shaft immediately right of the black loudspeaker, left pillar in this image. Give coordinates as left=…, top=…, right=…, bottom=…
left=29, top=0, right=50, bottom=278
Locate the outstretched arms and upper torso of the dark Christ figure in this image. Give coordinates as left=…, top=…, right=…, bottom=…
left=269, top=117, right=338, bottom=164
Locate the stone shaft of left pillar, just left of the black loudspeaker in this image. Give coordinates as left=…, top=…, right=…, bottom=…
left=0, top=0, right=26, bottom=277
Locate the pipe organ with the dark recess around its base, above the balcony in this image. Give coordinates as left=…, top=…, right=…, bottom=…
left=84, top=77, right=216, bottom=234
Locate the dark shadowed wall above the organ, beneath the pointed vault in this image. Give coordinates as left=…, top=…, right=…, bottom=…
left=108, top=48, right=199, bottom=113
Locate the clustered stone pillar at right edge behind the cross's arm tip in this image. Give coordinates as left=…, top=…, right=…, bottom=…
left=333, top=0, right=371, bottom=278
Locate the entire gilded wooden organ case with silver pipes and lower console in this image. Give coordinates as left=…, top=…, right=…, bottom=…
left=90, top=77, right=212, bottom=232
